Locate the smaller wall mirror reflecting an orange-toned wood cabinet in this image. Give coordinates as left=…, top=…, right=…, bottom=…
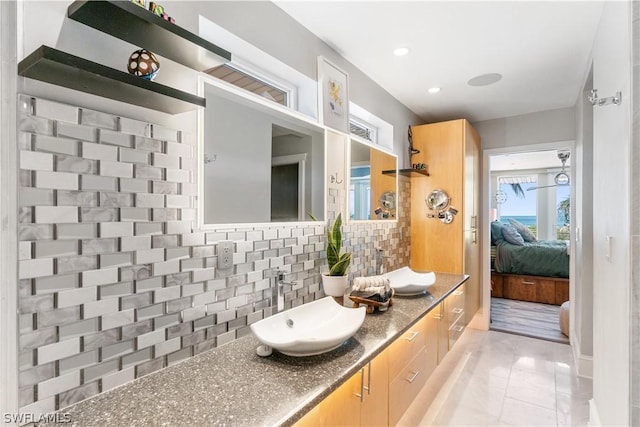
left=348, top=138, right=398, bottom=221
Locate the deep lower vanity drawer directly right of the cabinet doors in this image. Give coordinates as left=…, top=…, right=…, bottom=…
left=389, top=351, right=428, bottom=425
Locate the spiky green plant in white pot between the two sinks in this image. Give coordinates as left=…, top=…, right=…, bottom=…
left=322, top=213, right=351, bottom=297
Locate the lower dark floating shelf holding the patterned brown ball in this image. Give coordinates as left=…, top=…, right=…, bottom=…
left=18, top=46, right=205, bottom=114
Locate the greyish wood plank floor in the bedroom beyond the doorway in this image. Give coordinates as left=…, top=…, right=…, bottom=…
left=489, top=298, right=569, bottom=344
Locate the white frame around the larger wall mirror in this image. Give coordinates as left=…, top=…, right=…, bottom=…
left=195, top=75, right=328, bottom=230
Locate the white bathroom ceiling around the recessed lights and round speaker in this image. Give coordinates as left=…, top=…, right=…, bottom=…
left=275, top=1, right=602, bottom=122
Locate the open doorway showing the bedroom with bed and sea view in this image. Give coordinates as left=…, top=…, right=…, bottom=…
left=488, top=147, right=572, bottom=344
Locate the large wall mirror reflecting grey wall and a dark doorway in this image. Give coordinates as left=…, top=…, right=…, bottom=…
left=198, top=78, right=325, bottom=226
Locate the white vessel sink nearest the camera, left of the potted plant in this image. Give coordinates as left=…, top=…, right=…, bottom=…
left=251, top=297, right=366, bottom=357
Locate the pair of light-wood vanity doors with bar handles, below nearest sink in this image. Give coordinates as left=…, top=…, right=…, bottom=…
left=295, top=350, right=389, bottom=426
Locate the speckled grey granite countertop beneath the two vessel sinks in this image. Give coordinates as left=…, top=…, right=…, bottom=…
left=50, top=273, right=468, bottom=426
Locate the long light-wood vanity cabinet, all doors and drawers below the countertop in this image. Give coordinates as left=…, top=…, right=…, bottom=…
left=295, top=285, right=466, bottom=426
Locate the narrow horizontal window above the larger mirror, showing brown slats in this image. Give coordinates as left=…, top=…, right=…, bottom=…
left=206, top=64, right=292, bottom=107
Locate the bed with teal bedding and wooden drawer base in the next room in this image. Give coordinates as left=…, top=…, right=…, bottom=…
left=491, top=221, right=569, bottom=305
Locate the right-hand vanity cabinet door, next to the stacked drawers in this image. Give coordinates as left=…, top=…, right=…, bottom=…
left=360, top=351, right=389, bottom=426
